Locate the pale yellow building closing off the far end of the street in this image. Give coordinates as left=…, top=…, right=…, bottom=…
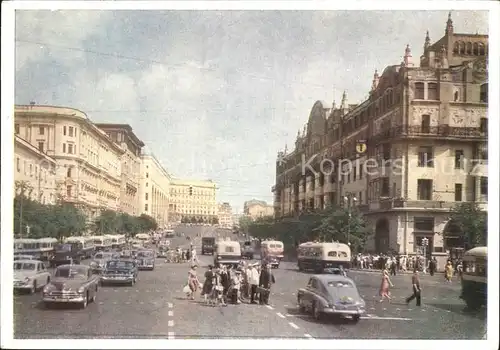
left=169, top=179, right=217, bottom=223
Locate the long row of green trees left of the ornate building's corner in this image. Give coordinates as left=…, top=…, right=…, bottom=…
left=246, top=207, right=366, bottom=251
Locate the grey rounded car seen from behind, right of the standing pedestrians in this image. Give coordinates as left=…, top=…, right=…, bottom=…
left=297, top=275, right=366, bottom=322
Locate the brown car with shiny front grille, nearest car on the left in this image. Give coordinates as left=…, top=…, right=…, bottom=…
left=42, top=265, right=100, bottom=308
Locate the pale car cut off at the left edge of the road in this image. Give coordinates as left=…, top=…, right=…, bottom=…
left=14, top=259, right=50, bottom=294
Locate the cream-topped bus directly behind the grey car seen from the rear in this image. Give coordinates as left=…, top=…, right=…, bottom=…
left=297, top=242, right=351, bottom=273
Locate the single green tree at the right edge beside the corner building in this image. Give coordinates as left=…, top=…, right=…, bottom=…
left=450, top=202, right=488, bottom=249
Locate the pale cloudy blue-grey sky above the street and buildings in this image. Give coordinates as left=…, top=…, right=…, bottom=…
left=15, top=10, right=488, bottom=212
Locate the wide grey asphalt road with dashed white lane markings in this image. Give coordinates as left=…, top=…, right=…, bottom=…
left=14, top=227, right=486, bottom=339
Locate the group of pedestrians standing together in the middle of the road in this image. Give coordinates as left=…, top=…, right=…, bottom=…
left=183, top=262, right=276, bottom=306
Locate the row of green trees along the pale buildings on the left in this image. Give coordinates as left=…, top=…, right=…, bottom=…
left=14, top=182, right=158, bottom=239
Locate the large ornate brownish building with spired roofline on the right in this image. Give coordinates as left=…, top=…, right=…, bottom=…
left=273, top=13, right=488, bottom=256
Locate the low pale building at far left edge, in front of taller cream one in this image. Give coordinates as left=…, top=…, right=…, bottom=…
left=14, top=135, right=57, bottom=204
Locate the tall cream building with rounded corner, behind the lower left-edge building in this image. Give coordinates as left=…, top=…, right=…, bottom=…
left=15, top=104, right=125, bottom=219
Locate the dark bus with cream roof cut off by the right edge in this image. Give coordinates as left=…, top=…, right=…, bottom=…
left=460, top=247, right=488, bottom=310
